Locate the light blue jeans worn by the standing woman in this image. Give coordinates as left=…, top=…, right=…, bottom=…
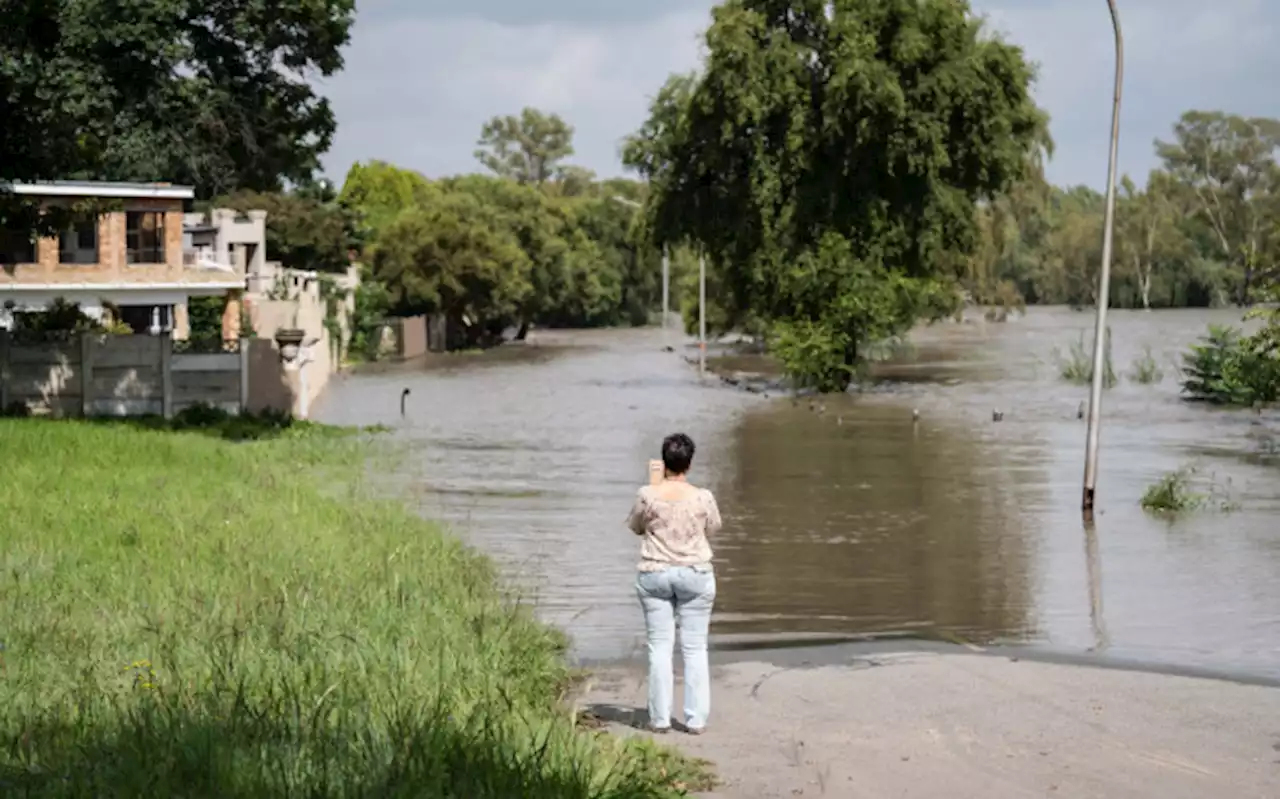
left=636, top=566, right=716, bottom=730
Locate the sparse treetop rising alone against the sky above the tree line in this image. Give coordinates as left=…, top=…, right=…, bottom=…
left=476, top=108, right=573, bottom=186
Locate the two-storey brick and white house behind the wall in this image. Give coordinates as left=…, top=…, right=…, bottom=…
left=0, top=181, right=259, bottom=338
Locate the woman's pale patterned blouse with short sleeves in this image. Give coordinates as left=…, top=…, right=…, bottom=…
left=627, top=485, right=721, bottom=571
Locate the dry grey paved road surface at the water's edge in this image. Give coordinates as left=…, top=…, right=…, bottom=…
left=582, top=650, right=1280, bottom=799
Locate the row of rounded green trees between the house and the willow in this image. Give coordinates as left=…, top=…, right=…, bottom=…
left=340, top=130, right=680, bottom=348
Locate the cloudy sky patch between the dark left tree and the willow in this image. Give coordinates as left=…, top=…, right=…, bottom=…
left=323, top=12, right=707, bottom=179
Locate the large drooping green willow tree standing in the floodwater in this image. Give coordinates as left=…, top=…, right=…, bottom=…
left=625, top=0, right=1046, bottom=391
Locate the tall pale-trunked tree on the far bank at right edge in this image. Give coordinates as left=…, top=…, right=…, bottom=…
left=1156, top=111, right=1280, bottom=306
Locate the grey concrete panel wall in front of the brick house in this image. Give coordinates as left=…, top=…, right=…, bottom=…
left=0, top=332, right=294, bottom=417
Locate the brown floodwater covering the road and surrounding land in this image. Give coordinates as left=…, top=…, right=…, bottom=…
left=319, top=309, right=1280, bottom=677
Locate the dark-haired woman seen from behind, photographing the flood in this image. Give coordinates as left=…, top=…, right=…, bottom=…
left=627, top=433, right=721, bottom=735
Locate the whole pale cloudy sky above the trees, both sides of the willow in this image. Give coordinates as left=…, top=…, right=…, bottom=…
left=317, top=0, right=1280, bottom=188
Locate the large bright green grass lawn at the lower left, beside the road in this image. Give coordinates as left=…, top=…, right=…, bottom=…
left=0, top=419, right=709, bottom=799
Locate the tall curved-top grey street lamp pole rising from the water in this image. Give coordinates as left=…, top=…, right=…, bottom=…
left=1080, top=0, right=1124, bottom=521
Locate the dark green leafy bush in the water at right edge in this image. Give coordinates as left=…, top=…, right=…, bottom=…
left=1183, top=325, right=1280, bottom=407
